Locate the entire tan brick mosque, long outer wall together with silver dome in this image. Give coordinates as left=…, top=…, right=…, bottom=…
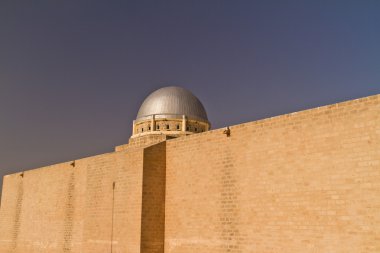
left=0, top=86, right=380, bottom=253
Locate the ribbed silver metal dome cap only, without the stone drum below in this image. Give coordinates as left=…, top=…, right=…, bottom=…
left=136, top=86, right=208, bottom=122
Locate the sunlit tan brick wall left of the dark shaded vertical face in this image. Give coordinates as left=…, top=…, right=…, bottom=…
left=0, top=149, right=148, bottom=253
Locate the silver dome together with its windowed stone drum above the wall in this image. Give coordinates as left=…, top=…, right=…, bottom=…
left=131, top=87, right=210, bottom=141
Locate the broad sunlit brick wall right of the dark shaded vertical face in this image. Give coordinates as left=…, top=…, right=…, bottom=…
left=165, top=95, right=380, bottom=253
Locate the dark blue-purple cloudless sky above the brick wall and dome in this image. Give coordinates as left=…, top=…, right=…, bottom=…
left=0, top=0, right=380, bottom=195
